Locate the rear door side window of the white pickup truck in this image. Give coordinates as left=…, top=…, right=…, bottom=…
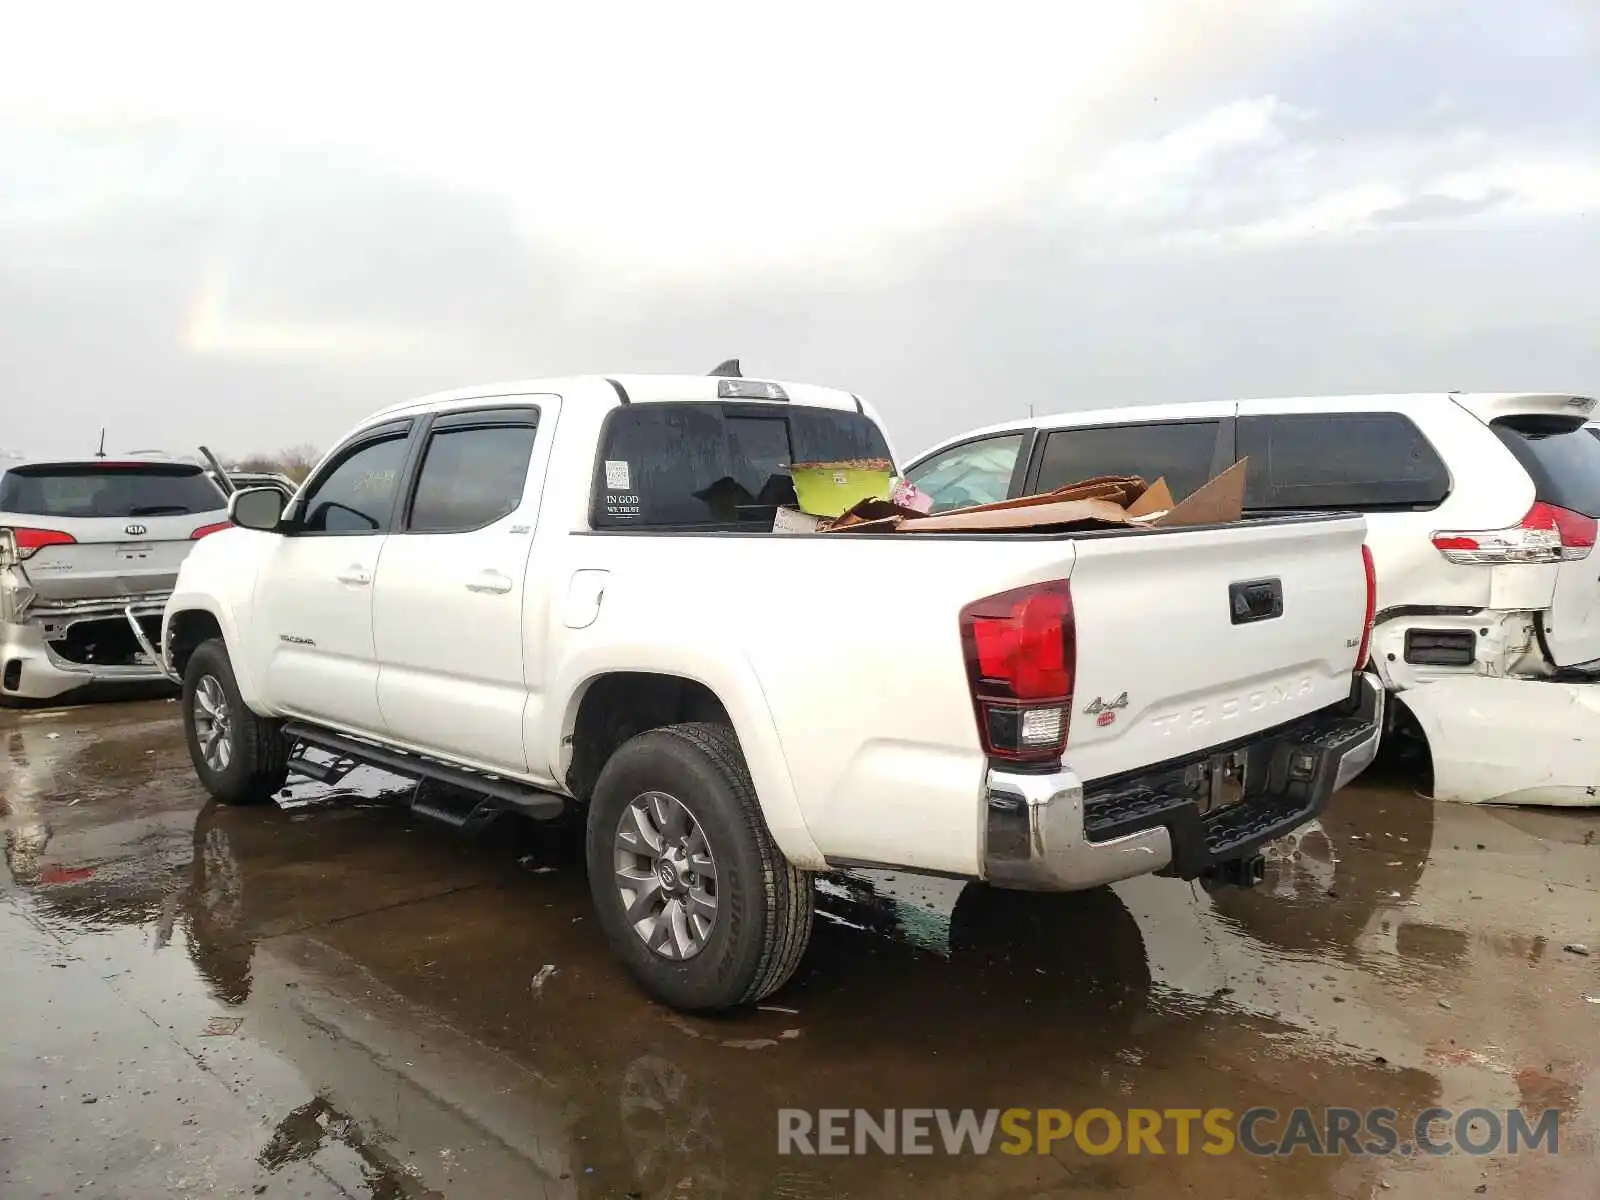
left=406, top=424, right=534, bottom=533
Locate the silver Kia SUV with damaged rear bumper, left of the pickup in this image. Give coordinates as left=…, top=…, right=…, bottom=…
left=0, top=456, right=227, bottom=706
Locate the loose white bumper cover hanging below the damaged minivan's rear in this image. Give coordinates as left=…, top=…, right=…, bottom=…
left=1400, top=675, right=1600, bottom=806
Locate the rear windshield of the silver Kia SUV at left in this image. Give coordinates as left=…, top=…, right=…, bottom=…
left=0, top=462, right=227, bottom=518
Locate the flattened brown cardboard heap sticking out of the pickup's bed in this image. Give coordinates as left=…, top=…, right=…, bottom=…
left=835, top=459, right=1248, bottom=533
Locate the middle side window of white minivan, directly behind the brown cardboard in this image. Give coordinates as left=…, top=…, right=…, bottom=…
left=1034, top=421, right=1218, bottom=499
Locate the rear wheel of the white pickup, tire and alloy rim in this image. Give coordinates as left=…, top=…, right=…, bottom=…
left=586, top=723, right=814, bottom=1011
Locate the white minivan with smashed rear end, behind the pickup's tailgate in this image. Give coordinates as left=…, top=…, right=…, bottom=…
left=907, top=392, right=1600, bottom=805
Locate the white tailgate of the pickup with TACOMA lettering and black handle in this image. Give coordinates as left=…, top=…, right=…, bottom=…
left=1067, top=515, right=1368, bottom=781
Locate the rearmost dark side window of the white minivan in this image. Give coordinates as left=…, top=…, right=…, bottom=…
left=1238, top=413, right=1450, bottom=512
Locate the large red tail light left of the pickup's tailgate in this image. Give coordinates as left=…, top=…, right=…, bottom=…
left=962, top=579, right=1077, bottom=763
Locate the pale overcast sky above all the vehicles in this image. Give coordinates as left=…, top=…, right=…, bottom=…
left=0, top=0, right=1600, bottom=454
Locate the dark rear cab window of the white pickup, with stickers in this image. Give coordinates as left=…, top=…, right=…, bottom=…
left=590, top=403, right=890, bottom=530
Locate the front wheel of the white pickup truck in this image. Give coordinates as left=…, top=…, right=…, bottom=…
left=182, top=637, right=291, bottom=805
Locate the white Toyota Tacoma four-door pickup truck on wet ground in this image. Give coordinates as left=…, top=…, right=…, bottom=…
left=158, top=376, right=1382, bottom=1010
